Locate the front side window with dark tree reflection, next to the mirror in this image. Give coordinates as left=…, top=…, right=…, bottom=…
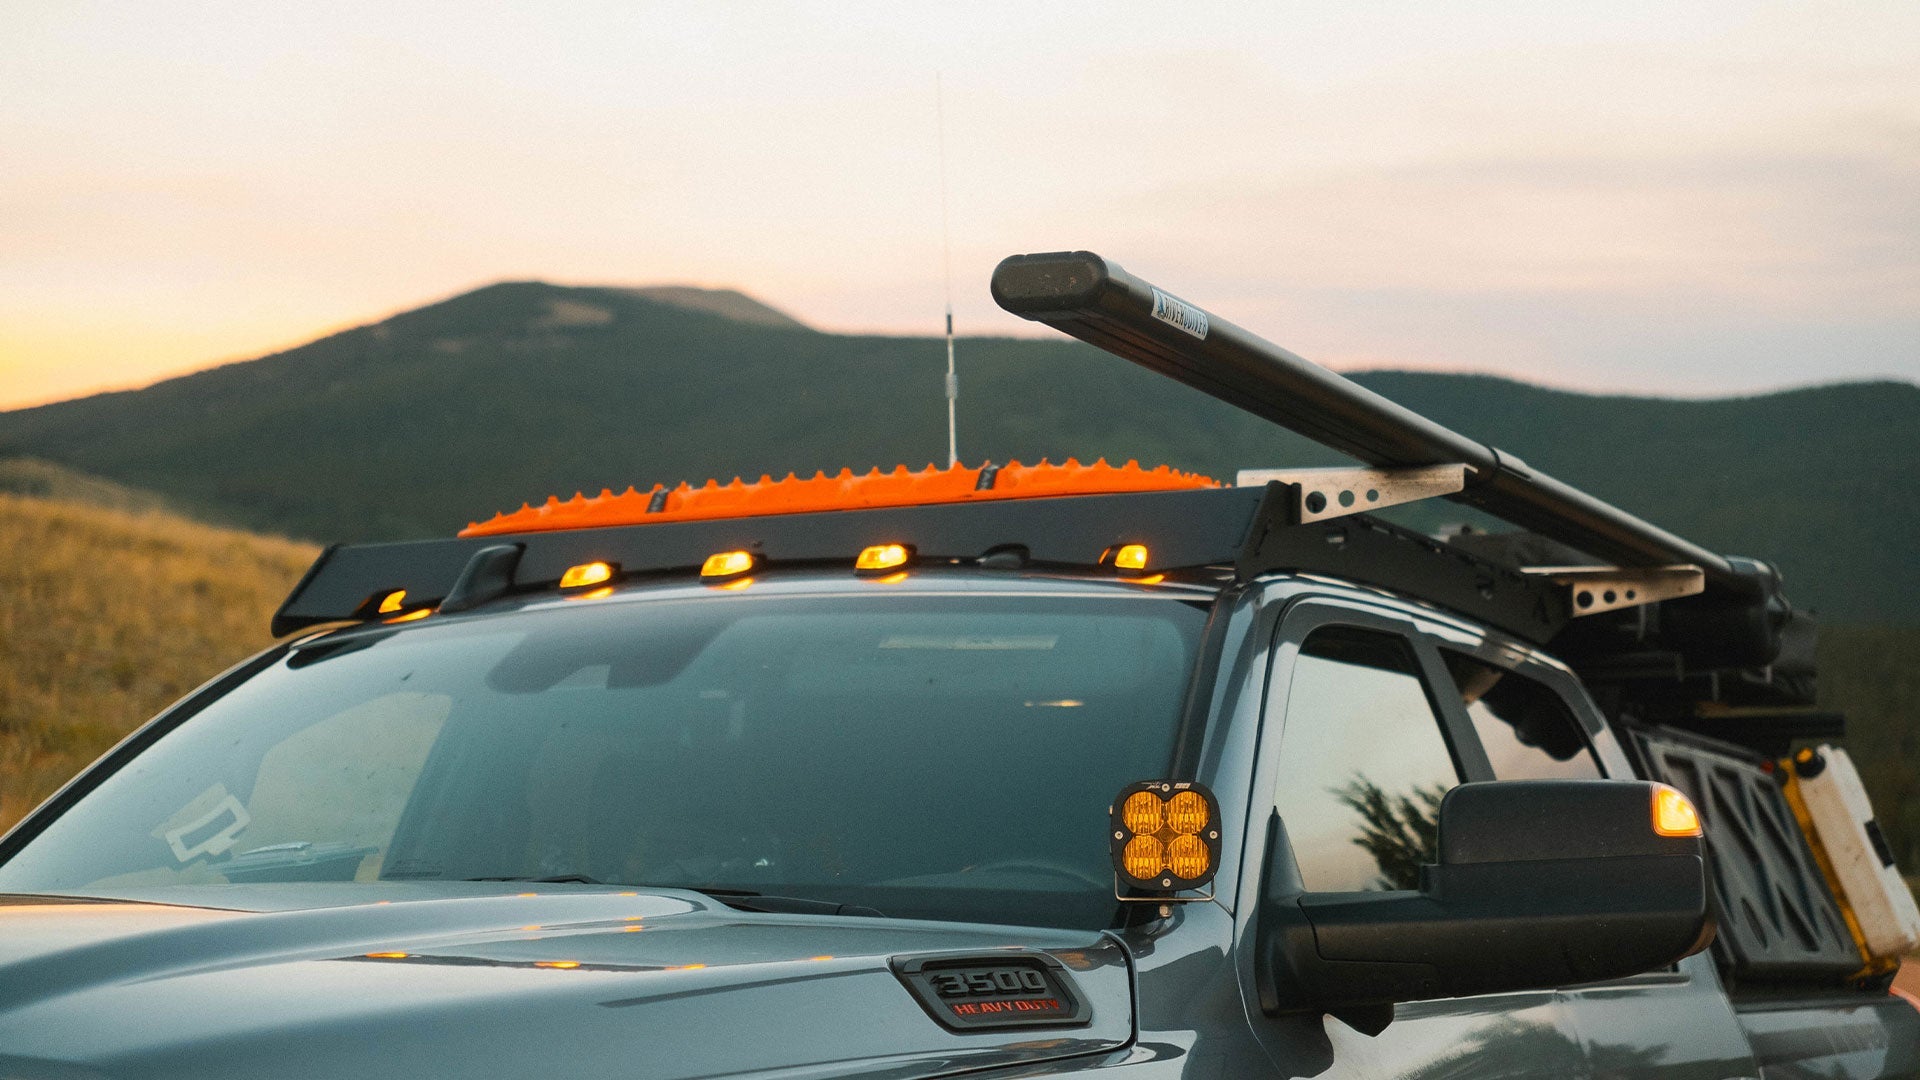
left=1273, top=626, right=1459, bottom=892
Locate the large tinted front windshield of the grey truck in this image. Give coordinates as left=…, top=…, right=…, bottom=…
left=0, top=592, right=1206, bottom=928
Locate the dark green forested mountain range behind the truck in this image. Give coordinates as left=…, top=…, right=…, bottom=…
left=0, top=281, right=1920, bottom=623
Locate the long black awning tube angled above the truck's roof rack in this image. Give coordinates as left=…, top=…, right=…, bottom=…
left=993, top=252, right=1778, bottom=603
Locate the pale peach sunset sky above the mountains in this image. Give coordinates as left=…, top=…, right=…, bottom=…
left=0, top=0, right=1920, bottom=407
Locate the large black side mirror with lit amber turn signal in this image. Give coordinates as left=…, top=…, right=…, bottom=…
left=1258, top=780, right=1713, bottom=1030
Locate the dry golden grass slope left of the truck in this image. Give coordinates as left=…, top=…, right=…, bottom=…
left=0, top=494, right=319, bottom=832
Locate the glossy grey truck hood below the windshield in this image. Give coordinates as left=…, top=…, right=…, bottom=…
left=0, top=886, right=1133, bottom=1080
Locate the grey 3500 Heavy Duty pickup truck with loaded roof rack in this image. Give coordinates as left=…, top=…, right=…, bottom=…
left=0, top=252, right=1920, bottom=1080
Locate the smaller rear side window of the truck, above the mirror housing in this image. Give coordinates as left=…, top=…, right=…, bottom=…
left=1440, top=650, right=1599, bottom=780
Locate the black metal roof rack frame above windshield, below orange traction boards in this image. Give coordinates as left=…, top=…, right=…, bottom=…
left=273, top=484, right=1571, bottom=642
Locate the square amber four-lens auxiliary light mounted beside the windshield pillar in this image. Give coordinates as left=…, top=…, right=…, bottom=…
left=1108, top=780, right=1219, bottom=901
